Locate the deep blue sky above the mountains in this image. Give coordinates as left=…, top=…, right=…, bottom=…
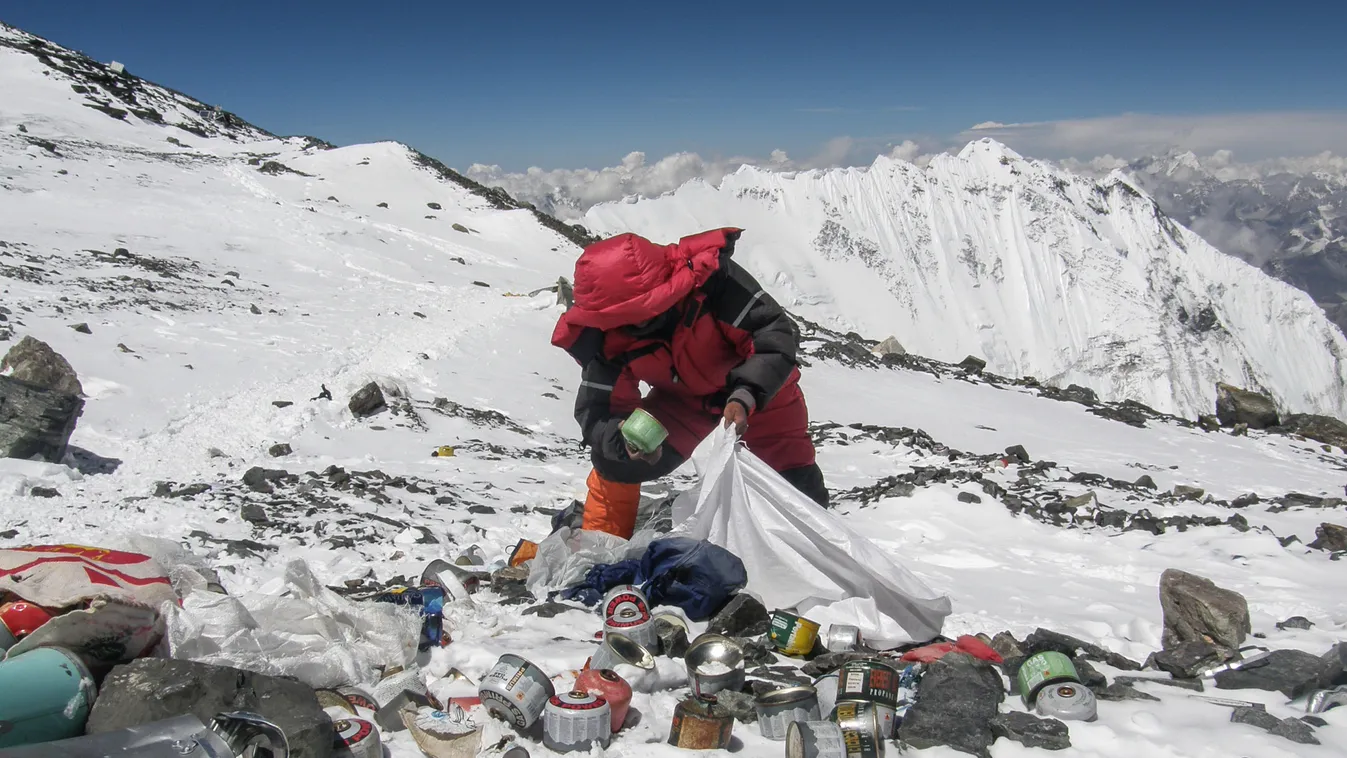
left=0, top=0, right=1347, bottom=170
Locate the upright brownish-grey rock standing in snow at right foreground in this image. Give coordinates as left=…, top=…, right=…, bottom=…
left=1160, top=568, right=1253, bottom=650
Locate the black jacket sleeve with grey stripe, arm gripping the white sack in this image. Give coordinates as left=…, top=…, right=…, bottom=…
left=702, top=257, right=800, bottom=411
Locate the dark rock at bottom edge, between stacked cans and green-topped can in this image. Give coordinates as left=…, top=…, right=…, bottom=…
left=898, top=653, right=1005, bottom=758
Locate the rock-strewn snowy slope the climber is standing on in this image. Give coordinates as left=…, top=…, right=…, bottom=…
left=0, top=20, right=1347, bottom=758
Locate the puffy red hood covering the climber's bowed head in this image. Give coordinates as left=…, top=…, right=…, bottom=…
left=552, top=228, right=741, bottom=346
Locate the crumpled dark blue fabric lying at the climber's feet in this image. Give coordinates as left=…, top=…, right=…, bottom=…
left=562, top=537, right=748, bottom=621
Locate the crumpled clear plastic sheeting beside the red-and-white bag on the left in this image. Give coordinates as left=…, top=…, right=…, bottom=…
left=162, top=560, right=420, bottom=688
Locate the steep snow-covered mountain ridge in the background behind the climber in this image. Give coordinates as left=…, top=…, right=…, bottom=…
left=586, top=146, right=1347, bottom=416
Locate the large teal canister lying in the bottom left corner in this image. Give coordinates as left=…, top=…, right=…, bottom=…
left=0, top=648, right=97, bottom=749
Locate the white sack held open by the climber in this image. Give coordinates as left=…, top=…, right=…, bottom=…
left=674, top=427, right=951, bottom=648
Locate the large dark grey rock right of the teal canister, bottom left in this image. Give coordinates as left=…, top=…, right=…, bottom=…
left=86, top=658, right=333, bottom=758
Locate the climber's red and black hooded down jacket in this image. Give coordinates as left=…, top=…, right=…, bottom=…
left=552, top=228, right=814, bottom=470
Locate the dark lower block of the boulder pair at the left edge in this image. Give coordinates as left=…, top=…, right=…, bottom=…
left=0, top=374, right=84, bottom=463
